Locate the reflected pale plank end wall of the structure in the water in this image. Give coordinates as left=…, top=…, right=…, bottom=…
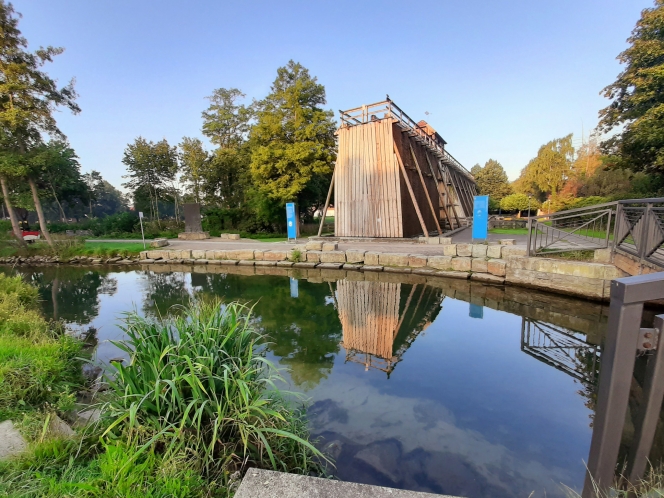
left=337, top=280, right=401, bottom=360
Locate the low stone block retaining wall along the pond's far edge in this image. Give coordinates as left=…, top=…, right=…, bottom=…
left=140, top=243, right=625, bottom=300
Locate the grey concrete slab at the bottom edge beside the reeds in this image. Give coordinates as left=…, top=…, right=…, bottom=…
left=235, top=469, right=453, bottom=498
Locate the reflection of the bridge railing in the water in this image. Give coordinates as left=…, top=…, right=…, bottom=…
left=521, top=317, right=599, bottom=383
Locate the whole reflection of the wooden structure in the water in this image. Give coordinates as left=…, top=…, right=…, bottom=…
left=337, top=280, right=443, bottom=375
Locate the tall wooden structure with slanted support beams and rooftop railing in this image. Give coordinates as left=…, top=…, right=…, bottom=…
left=321, top=98, right=476, bottom=238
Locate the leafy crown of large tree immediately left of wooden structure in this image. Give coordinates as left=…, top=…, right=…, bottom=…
left=250, top=61, right=336, bottom=220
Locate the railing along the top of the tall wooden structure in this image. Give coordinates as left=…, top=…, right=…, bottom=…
left=339, top=97, right=474, bottom=181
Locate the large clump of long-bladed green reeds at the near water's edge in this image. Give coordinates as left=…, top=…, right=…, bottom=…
left=105, top=301, right=322, bottom=485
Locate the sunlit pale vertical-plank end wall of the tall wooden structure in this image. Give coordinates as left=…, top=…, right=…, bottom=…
left=334, top=119, right=404, bottom=237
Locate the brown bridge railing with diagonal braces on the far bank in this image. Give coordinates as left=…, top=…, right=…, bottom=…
left=528, top=197, right=664, bottom=267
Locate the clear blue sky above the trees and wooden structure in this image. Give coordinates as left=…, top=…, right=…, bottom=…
left=14, top=0, right=652, bottom=186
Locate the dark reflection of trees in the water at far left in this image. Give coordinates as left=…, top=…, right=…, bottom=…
left=22, top=266, right=118, bottom=325
